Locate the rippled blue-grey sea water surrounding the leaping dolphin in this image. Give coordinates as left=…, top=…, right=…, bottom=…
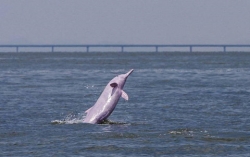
left=0, top=52, right=250, bottom=157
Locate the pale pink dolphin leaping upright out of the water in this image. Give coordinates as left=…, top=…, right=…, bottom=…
left=84, top=69, right=133, bottom=124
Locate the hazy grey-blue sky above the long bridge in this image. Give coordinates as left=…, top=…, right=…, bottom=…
left=0, top=0, right=250, bottom=44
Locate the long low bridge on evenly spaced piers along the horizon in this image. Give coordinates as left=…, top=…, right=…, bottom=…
left=0, top=44, right=250, bottom=52
